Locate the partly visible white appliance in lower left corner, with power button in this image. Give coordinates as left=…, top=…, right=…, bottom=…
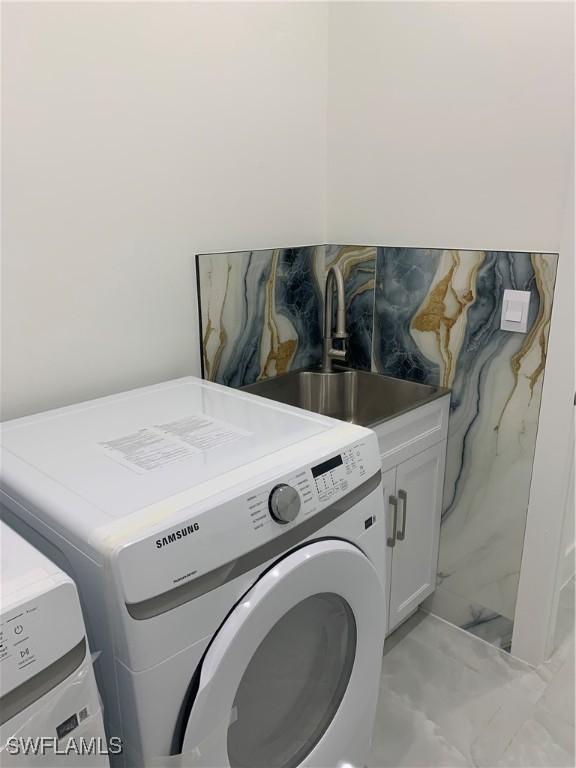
left=0, top=523, right=109, bottom=768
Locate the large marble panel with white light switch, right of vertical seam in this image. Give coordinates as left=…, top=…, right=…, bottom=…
left=373, top=248, right=557, bottom=647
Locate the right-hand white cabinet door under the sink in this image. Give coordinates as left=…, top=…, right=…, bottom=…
left=388, top=441, right=446, bottom=631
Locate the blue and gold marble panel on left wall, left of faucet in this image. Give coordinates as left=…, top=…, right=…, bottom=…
left=196, top=246, right=324, bottom=387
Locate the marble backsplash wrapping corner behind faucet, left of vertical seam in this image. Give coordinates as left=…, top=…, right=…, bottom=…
left=197, top=245, right=376, bottom=387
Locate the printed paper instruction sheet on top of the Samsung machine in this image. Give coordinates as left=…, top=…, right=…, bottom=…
left=98, top=414, right=252, bottom=473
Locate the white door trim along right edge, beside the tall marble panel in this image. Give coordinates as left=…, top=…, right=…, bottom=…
left=512, top=155, right=575, bottom=664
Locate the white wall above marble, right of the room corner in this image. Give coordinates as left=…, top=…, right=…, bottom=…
left=327, top=2, right=573, bottom=251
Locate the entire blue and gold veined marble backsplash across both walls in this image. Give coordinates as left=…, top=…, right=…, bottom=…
left=197, top=245, right=557, bottom=648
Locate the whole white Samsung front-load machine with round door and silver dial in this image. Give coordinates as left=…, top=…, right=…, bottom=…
left=1, top=377, right=387, bottom=768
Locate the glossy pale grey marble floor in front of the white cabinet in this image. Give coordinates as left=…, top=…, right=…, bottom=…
left=368, top=612, right=574, bottom=768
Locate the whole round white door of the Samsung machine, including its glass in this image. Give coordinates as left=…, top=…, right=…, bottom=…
left=178, top=539, right=386, bottom=768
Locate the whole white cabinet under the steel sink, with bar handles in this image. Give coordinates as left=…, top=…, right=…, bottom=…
left=375, top=397, right=449, bottom=632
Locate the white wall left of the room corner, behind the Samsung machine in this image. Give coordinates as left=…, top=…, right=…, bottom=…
left=2, top=3, right=327, bottom=418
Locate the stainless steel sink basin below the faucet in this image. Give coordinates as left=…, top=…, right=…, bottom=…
left=242, top=370, right=450, bottom=427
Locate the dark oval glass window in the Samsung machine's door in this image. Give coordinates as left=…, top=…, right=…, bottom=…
left=228, top=592, right=356, bottom=768
